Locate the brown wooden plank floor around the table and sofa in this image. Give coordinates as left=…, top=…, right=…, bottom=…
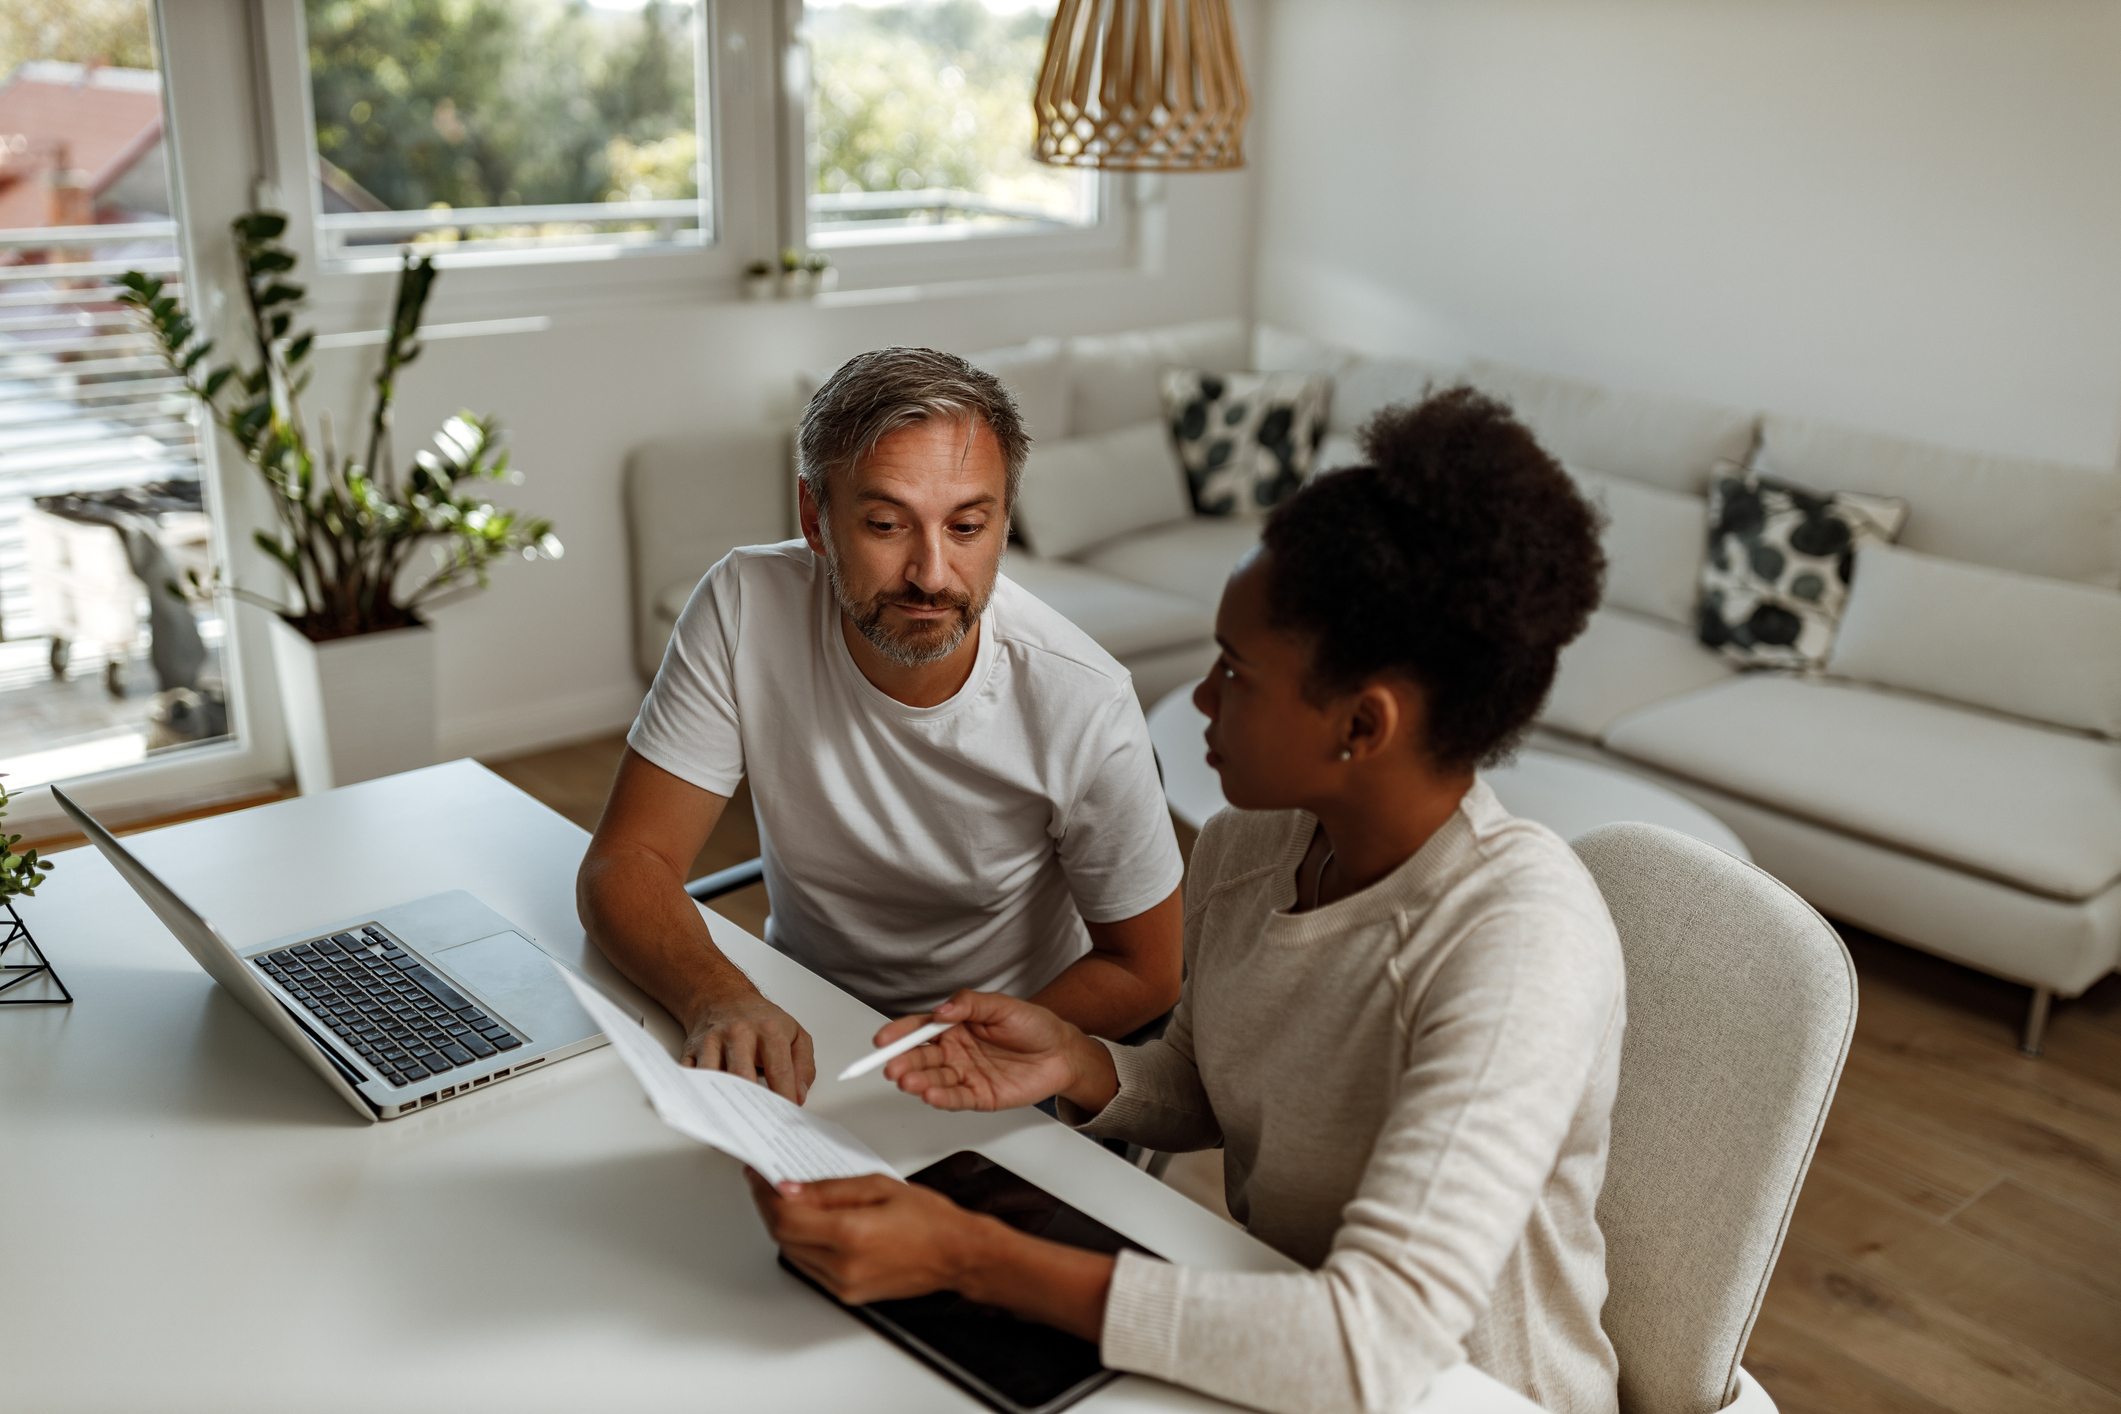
left=488, top=738, right=2121, bottom=1414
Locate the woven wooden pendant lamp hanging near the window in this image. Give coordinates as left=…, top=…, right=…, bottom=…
left=1031, top=0, right=1251, bottom=172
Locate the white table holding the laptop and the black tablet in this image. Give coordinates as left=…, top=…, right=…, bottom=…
left=0, top=761, right=1536, bottom=1414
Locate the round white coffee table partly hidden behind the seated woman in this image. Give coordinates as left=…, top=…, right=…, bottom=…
left=1150, top=683, right=1752, bottom=861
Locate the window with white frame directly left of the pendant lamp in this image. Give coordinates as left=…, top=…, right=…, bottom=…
left=791, top=0, right=1124, bottom=282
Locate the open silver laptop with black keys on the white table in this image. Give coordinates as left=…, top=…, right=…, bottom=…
left=51, top=786, right=638, bottom=1119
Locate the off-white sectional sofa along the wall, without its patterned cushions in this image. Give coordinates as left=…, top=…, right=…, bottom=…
left=630, top=320, right=2121, bottom=1049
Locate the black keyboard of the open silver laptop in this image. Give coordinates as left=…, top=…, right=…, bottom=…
left=252, top=924, right=522, bottom=1085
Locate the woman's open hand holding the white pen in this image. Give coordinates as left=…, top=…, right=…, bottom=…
left=876, top=992, right=1120, bottom=1111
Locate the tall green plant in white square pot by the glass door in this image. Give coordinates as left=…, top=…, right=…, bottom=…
left=119, top=212, right=562, bottom=795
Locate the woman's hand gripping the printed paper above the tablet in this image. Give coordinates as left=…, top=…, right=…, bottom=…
left=744, top=1168, right=995, bottom=1306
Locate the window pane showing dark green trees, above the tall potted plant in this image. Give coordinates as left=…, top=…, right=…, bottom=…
left=303, top=0, right=715, bottom=269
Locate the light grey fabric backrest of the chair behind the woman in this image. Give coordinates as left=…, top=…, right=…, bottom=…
left=1576, top=825, right=1856, bottom=1414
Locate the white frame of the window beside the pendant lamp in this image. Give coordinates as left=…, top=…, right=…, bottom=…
left=776, top=0, right=1141, bottom=293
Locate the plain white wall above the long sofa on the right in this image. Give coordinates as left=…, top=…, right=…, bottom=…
left=1251, top=0, right=2121, bottom=466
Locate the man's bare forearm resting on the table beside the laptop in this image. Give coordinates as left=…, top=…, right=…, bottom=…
left=579, top=850, right=757, bottom=1026
